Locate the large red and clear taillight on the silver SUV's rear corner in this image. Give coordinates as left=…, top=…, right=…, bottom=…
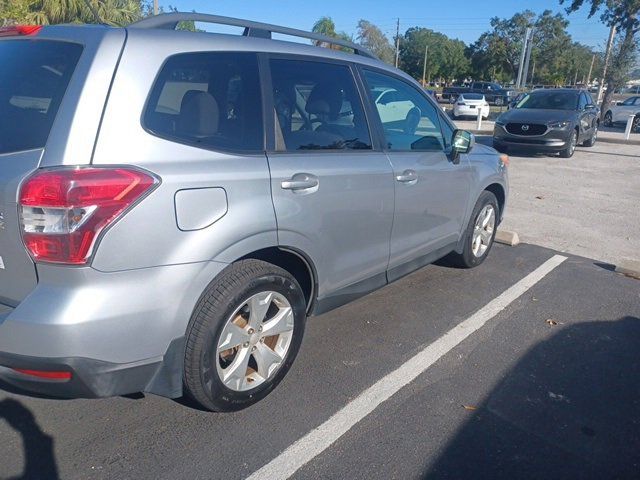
left=19, top=168, right=157, bottom=265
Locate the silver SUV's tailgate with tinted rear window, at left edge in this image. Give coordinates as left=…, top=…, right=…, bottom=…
left=0, top=38, right=82, bottom=305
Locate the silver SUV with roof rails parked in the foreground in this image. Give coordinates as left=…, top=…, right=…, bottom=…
left=0, top=13, right=508, bottom=411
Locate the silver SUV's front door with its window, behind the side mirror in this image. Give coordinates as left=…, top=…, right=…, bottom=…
left=363, top=69, right=471, bottom=280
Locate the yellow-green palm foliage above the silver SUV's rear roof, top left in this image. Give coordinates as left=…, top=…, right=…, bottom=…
left=0, top=0, right=144, bottom=26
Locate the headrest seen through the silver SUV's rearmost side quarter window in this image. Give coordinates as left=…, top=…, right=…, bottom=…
left=177, top=90, right=220, bottom=138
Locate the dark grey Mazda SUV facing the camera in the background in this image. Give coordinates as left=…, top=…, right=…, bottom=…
left=493, top=88, right=599, bottom=158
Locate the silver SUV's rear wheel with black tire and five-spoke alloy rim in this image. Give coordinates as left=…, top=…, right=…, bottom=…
left=183, top=260, right=306, bottom=412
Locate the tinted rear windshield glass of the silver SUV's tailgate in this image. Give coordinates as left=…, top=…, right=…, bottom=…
left=0, top=40, right=82, bottom=154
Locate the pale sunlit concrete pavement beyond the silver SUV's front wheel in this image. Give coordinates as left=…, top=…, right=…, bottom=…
left=478, top=136, right=640, bottom=265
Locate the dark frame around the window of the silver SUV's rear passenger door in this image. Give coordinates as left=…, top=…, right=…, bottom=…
left=261, top=52, right=382, bottom=155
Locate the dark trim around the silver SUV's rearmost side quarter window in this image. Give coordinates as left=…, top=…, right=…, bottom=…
left=140, top=50, right=267, bottom=157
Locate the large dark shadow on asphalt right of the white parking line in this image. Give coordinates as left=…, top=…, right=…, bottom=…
left=423, top=317, right=640, bottom=480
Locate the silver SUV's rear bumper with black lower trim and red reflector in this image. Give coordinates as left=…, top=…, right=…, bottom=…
left=0, top=262, right=226, bottom=398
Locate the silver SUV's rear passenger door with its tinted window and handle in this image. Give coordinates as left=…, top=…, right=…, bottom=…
left=268, top=56, right=395, bottom=303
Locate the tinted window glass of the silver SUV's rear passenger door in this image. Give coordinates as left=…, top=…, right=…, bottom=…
left=271, top=59, right=371, bottom=151
